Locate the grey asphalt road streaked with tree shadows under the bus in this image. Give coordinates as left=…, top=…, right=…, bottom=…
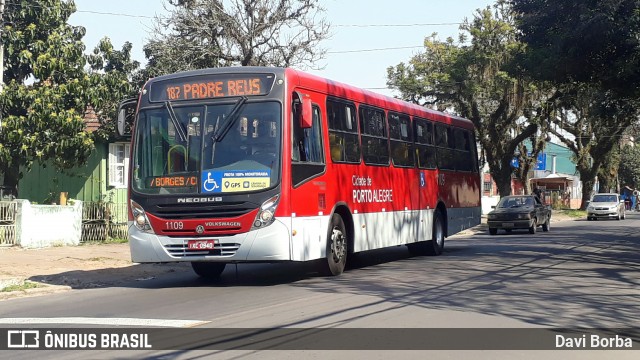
left=0, top=213, right=640, bottom=359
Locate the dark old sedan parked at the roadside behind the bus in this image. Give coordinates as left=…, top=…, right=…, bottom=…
left=487, top=195, right=551, bottom=235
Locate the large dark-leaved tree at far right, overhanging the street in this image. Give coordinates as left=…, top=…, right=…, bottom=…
left=510, top=0, right=640, bottom=208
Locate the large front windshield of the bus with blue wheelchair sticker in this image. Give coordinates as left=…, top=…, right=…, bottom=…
left=132, top=101, right=282, bottom=194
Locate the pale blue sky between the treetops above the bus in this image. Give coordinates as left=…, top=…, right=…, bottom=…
left=69, top=0, right=494, bottom=95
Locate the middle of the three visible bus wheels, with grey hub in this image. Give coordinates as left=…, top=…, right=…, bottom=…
left=323, top=214, right=349, bottom=276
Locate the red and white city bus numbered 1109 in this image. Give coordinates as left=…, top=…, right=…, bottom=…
left=118, top=67, right=481, bottom=278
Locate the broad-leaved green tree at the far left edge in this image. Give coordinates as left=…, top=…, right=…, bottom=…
left=0, top=0, right=93, bottom=193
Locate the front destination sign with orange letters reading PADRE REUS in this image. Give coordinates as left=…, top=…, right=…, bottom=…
left=149, top=74, right=275, bottom=102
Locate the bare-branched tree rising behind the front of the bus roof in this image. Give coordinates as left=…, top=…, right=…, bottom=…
left=144, top=0, right=329, bottom=76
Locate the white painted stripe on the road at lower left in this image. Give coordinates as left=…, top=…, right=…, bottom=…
left=0, top=317, right=210, bottom=328
